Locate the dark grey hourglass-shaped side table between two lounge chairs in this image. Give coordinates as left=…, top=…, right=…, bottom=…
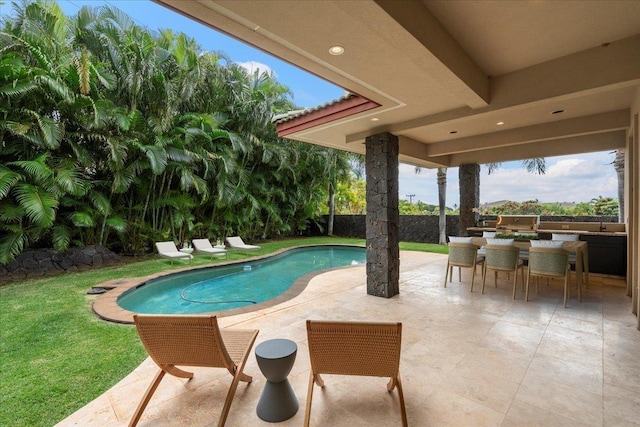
left=255, top=339, right=298, bottom=423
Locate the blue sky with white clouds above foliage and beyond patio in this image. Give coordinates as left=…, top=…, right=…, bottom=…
left=12, top=0, right=617, bottom=206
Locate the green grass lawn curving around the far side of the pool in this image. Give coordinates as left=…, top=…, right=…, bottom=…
left=0, top=237, right=447, bottom=426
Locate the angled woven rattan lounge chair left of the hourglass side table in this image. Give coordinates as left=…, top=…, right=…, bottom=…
left=129, top=314, right=258, bottom=427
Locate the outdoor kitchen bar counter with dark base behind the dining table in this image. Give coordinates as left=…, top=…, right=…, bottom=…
left=467, top=221, right=627, bottom=277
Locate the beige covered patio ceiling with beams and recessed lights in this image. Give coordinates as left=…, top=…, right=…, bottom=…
left=156, top=0, right=640, bottom=167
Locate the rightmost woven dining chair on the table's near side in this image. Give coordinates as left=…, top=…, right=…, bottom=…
left=525, top=247, right=569, bottom=307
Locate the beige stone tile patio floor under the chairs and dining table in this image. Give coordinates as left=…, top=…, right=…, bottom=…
left=58, top=252, right=640, bottom=427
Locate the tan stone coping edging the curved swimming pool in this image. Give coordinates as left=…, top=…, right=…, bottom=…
left=91, top=244, right=363, bottom=324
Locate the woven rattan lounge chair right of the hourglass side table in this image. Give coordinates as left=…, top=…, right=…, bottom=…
left=304, top=320, right=407, bottom=427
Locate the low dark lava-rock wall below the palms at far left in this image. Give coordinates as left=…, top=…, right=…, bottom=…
left=0, top=246, right=120, bottom=282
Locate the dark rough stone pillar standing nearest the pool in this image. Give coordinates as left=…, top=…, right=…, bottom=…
left=365, top=133, right=400, bottom=298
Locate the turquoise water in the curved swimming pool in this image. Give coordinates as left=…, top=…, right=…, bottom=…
left=117, top=246, right=366, bottom=314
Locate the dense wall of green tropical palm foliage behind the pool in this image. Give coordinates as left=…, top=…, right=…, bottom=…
left=0, top=0, right=356, bottom=263
